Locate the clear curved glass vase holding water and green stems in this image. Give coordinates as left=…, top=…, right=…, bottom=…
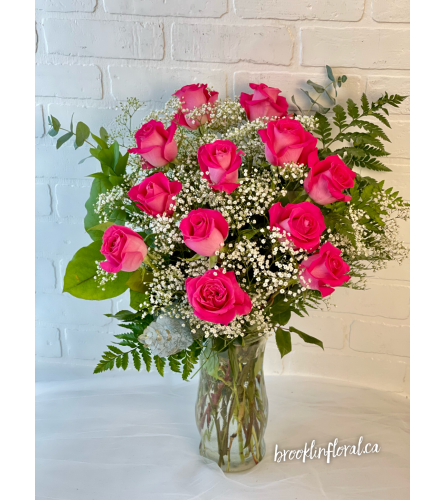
left=196, top=336, right=268, bottom=472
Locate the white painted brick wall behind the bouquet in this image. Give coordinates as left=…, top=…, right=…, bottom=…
left=35, top=0, right=410, bottom=393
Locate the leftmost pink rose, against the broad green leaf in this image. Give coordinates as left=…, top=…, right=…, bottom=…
left=100, top=224, right=147, bottom=273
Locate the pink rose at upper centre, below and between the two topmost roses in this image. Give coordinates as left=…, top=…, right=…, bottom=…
left=198, top=141, right=244, bottom=194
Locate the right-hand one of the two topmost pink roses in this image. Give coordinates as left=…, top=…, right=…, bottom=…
left=239, top=83, right=289, bottom=121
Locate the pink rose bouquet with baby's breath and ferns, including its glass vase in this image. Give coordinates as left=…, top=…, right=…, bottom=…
left=49, top=66, right=408, bottom=471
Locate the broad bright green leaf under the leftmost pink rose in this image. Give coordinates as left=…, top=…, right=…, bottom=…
left=63, top=241, right=130, bottom=300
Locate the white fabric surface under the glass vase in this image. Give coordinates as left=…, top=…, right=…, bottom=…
left=36, top=364, right=409, bottom=500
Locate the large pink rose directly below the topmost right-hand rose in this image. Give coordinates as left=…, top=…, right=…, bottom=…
left=258, top=118, right=317, bottom=167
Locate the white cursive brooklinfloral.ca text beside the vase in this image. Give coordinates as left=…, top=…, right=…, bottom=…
left=274, top=436, right=380, bottom=463
